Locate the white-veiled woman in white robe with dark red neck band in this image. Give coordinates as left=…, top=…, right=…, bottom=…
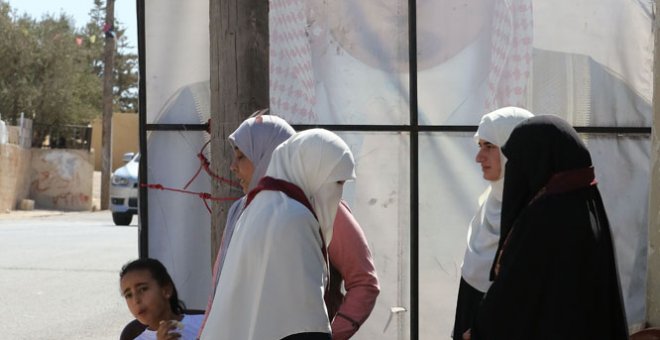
left=201, top=129, right=355, bottom=340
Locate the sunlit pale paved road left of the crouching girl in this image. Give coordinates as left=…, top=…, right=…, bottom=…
left=0, top=211, right=138, bottom=340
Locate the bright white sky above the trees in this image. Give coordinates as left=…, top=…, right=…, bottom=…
left=1, top=0, right=137, bottom=53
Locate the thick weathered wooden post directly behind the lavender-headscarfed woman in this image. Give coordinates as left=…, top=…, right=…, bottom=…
left=209, top=0, right=269, bottom=263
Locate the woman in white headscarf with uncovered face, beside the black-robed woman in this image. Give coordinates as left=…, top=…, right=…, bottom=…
left=452, top=106, right=533, bottom=339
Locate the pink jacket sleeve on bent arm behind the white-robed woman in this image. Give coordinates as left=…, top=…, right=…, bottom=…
left=326, top=201, right=380, bottom=340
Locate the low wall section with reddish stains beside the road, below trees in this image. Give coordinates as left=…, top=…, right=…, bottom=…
left=30, top=149, right=94, bottom=211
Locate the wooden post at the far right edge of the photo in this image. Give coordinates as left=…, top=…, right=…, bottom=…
left=646, top=0, right=660, bottom=327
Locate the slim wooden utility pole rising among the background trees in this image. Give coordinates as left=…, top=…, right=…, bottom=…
left=101, top=0, right=115, bottom=210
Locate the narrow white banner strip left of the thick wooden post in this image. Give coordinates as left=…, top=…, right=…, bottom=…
left=142, top=0, right=211, bottom=309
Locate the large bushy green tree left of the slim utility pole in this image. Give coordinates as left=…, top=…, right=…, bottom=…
left=0, top=3, right=100, bottom=125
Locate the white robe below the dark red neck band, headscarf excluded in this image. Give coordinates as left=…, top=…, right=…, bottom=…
left=201, top=191, right=330, bottom=340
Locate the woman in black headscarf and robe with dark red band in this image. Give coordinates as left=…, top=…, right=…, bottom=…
left=471, top=116, right=628, bottom=340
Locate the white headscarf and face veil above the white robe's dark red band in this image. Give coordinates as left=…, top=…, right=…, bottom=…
left=266, top=129, right=355, bottom=246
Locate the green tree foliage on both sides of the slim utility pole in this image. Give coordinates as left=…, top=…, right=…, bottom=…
left=0, top=0, right=137, bottom=126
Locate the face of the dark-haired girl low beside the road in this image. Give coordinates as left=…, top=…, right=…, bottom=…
left=120, top=269, right=173, bottom=330
